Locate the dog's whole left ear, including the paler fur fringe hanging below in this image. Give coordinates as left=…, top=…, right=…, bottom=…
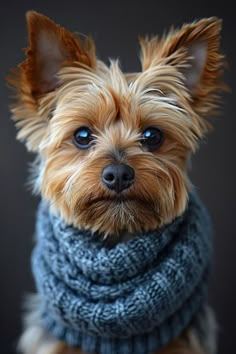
left=8, top=11, right=96, bottom=151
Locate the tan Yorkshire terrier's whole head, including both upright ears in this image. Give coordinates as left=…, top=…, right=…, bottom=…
left=8, top=12, right=222, bottom=235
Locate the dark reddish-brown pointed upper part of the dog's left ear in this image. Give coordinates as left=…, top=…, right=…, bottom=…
left=20, top=11, right=95, bottom=96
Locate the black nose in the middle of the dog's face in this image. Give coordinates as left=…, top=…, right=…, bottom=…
left=102, top=164, right=134, bottom=193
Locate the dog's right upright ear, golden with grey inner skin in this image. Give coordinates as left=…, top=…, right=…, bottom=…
left=140, top=17, right=224, bottom=114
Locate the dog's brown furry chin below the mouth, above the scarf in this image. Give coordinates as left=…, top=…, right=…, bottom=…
left=75, top=195, right=161, bottom=242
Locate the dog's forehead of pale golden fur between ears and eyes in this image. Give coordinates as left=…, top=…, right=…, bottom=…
left=52, top=62, right=191, bottom=134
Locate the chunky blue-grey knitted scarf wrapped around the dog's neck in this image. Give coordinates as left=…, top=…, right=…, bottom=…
left=32, top=193, right=212, bottom=354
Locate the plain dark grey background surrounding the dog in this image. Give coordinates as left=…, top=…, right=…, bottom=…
left=0, top=0, right=236, bottom=354
